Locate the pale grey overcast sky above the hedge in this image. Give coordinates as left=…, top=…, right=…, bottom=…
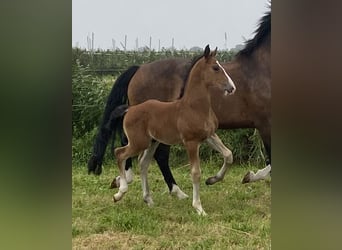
left=72, top=0, right=269, bottom=50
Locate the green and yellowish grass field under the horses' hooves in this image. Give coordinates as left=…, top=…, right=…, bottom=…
left=72, top=162, right=271, bottom=250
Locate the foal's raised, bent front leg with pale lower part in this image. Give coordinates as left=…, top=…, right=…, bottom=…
left=205, top=134, right=233, bottom=185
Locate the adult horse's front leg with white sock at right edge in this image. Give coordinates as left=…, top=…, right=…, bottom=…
left=242, top=126, right=271, bottom=183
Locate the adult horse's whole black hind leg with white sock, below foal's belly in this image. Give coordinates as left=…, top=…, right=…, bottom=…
left=154, top=143, right=189, bottom=199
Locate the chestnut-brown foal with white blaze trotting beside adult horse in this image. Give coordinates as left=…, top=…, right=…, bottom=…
left=110, top=45, right=236, bottom=215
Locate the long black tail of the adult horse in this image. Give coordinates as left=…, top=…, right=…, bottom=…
left=88, top=66, right=139, bottom=175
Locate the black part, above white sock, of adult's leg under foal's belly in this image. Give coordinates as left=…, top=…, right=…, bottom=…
left=154, top=143, right=177, bottom=192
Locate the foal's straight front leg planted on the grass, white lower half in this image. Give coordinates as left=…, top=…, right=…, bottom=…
left=185, top=142, right=207, bottom=215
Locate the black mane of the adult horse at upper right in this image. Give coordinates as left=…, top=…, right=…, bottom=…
left=236, top=6, right=271, bottom=57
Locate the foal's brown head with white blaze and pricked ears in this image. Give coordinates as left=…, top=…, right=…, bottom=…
left=198, top=45, right=236, bottom=94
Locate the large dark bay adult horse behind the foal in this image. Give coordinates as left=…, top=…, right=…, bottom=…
left=88, top=11, right=271, bottom=193
